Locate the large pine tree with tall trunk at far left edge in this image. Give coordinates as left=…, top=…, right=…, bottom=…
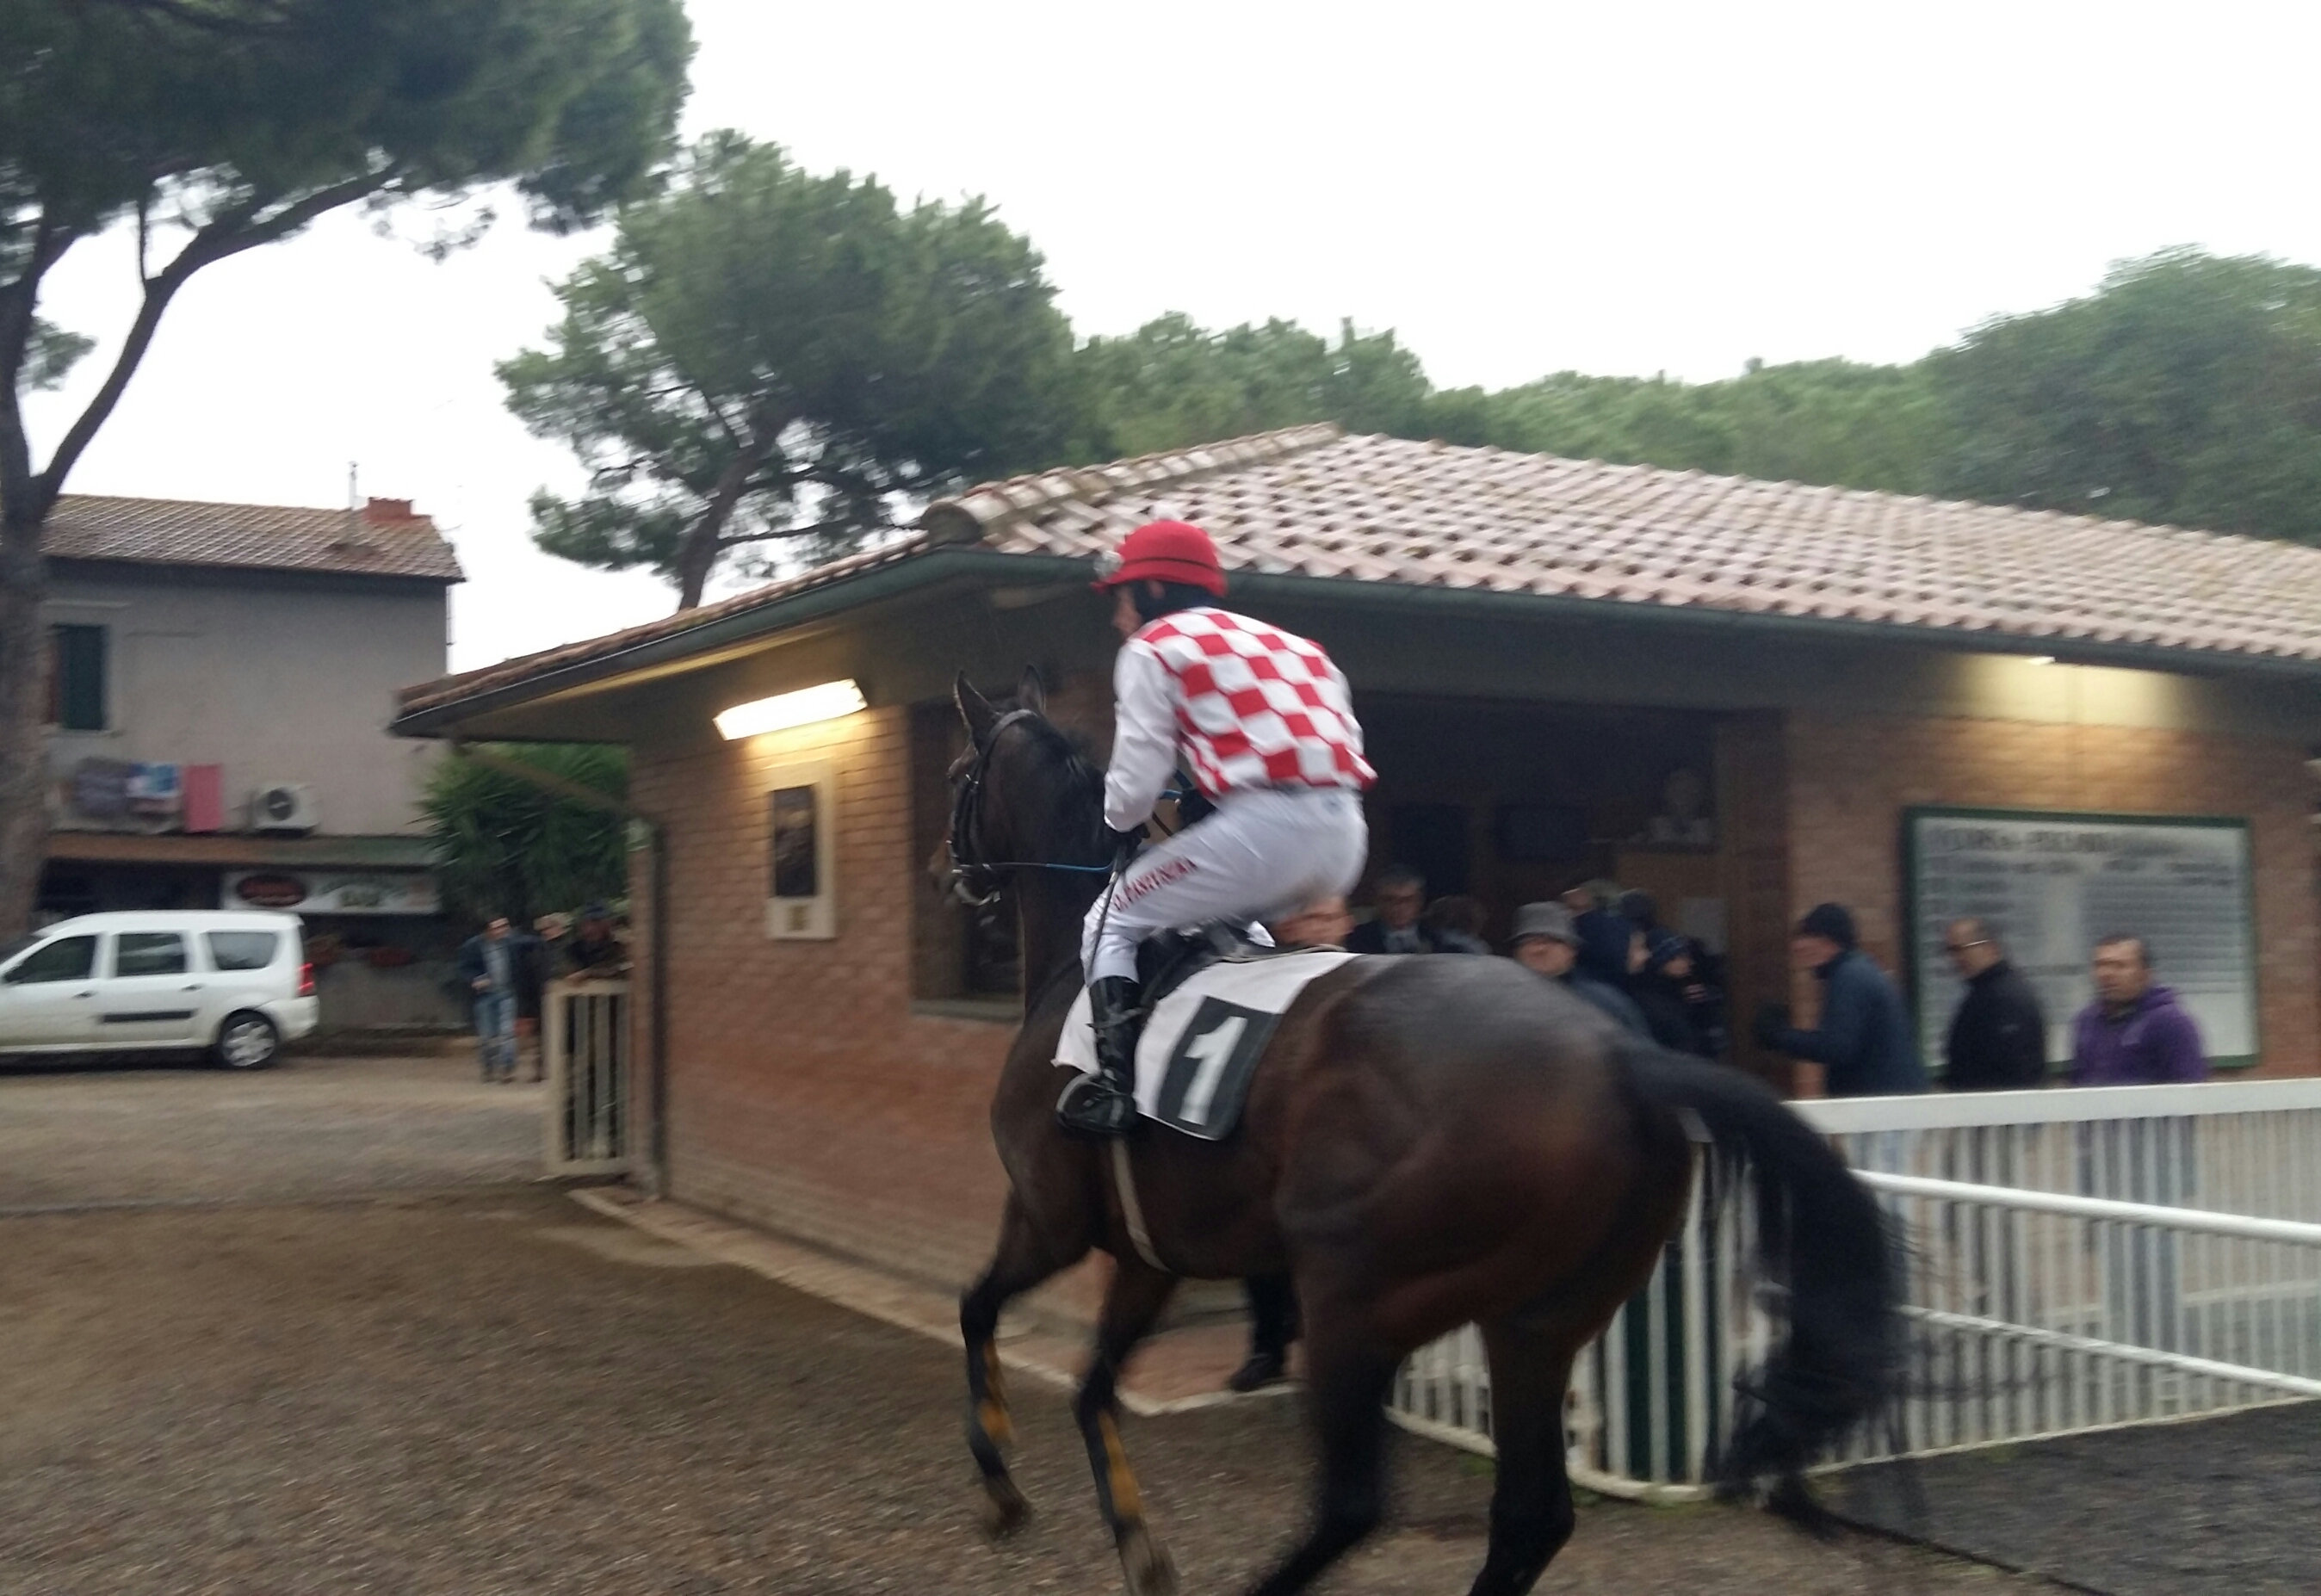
left=0, top=0, right=691, bottom=935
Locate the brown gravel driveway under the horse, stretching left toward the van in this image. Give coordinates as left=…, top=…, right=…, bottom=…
left=0, top=1061, right=2047, bottom=1596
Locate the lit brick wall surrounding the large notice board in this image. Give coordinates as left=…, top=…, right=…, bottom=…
left=1785, top=714, right=2321, bottom=1074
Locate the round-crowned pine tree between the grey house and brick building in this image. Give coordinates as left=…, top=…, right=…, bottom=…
left=499, top=133, right=1074, bottom=608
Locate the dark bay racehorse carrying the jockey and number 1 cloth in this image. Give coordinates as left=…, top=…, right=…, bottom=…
left=950, top=672, right=1901, bottom=1596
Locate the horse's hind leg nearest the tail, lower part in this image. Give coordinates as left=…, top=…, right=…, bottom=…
left=1467, top=1320, right=1574, bottom=1596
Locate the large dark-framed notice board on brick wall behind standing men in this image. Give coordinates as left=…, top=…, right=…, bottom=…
left=1903, top=807, right=2258, bottom=1069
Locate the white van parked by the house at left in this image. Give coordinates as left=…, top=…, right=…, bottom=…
left=0, top=909, right=316, bottom=1069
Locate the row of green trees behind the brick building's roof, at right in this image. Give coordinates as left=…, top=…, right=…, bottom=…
left=1053, top=251, right=2321, bottom=543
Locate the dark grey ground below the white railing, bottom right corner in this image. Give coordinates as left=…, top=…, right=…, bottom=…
left=1834, top=1403, right=2321, bottom=1596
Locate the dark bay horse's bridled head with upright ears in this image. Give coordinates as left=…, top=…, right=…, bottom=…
left=950, top=668, right=1105, bottom=905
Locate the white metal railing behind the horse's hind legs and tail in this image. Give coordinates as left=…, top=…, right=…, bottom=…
left=1390, top=1079, right=2321, bottom=1496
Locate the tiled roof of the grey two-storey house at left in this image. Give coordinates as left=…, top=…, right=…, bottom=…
left=42, top=494, right=460, bottom=582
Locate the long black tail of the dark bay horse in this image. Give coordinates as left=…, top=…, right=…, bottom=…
left=1625, top=1046, right=1903, bottom=1508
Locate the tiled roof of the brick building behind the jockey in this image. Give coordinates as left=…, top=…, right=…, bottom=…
left=389, top=424, right=2321, bottom=712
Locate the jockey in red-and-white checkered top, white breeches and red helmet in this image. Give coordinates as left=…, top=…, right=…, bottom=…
left=1056, top=522, right=1377, bottom=1136
